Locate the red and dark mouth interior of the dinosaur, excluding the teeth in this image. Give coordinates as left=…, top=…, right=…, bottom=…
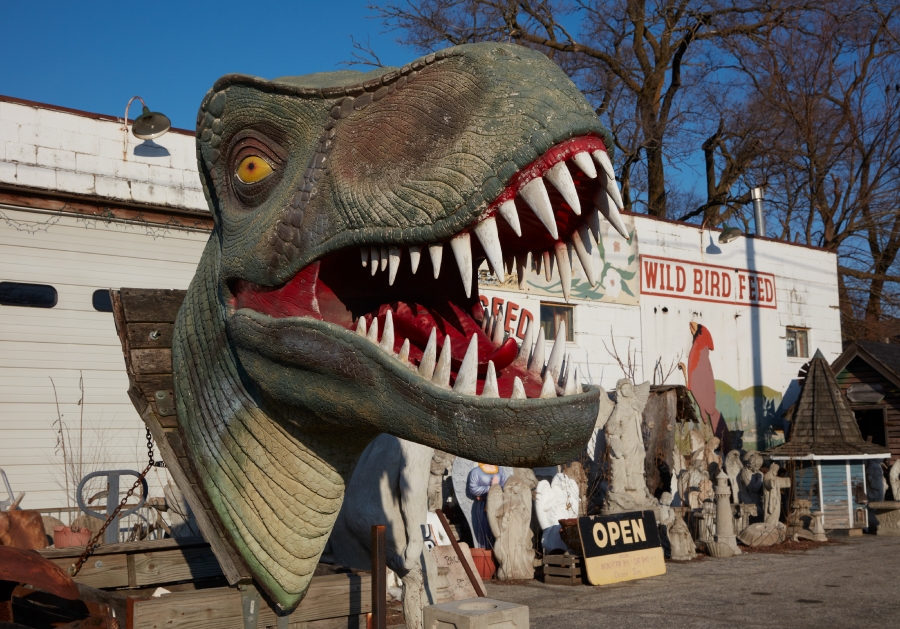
left=230, top=136, right=605, bottom=398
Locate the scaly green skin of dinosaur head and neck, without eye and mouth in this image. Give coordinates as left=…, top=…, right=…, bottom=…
left=173, top=44, right=612, bottom=609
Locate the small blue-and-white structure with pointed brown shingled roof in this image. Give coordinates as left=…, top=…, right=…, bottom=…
left=767, top=352, right=891, bottom=529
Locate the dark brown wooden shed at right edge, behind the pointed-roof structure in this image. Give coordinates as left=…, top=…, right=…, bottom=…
left=831, top=341, right=900, bottom=463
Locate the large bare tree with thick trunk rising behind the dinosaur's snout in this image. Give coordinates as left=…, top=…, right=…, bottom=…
left=373, top=0, right=803, bottom=217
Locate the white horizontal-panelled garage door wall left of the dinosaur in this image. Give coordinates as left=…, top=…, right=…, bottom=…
left=0, top=208, right=208, bottom=508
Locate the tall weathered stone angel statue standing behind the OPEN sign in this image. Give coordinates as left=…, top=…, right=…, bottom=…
left=606, top=378, right=658, bottom=513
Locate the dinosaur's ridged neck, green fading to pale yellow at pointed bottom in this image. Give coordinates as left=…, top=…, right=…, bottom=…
left=173, top=235, right=364, bottom=609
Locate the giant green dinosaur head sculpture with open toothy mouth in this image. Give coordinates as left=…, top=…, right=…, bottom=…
left=173, top=44, right=621, bottom=608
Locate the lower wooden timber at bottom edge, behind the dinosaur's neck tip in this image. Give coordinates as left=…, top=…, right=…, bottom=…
left=128, top=574, right=372, bottom=629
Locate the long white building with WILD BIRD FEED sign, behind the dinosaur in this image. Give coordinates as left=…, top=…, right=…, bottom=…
left=0, top=97, right=841, bottom=508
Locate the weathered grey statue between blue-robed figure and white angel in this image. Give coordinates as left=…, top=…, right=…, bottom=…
left=487, top=475, right=534, bottom=581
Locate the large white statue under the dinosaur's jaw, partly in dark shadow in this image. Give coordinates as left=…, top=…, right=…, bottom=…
left=329, top=434, right=437, bottom=629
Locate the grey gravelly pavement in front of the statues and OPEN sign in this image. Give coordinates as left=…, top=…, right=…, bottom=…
left=487, top=535, right=900, bottom=629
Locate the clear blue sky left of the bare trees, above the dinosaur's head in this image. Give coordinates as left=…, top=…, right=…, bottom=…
left=0, top=0, right=410, bottom=129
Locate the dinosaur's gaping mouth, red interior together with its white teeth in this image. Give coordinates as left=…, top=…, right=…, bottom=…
left=228, top=136, right=624, bottom=398
